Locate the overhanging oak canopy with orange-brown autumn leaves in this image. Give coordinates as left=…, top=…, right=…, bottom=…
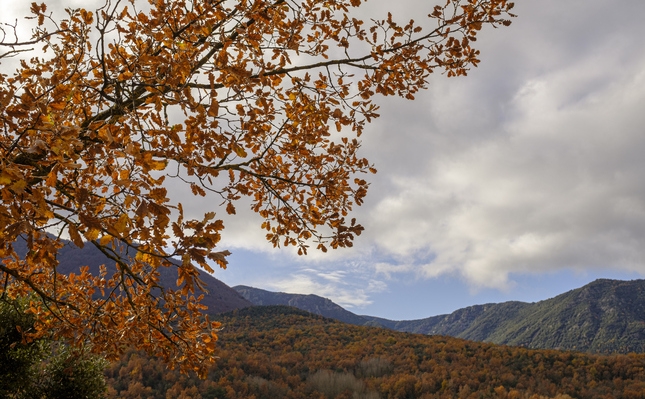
left=0, top=0, right=513, bottom=371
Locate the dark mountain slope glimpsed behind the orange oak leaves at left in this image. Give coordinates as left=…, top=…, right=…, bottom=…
left=14, top=240, right=253, bottom=314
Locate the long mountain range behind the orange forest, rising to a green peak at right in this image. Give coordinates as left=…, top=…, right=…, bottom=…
left=234, top=279, right=645, bottom=353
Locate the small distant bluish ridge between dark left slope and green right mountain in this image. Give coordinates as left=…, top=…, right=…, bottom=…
left=233, top=285, right=368, bottom=326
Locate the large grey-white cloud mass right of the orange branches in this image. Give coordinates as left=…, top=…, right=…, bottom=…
left=208, top=1, right=645, bottom=294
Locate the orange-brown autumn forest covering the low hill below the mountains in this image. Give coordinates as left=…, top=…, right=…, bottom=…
left=103, top=306, right=645, bottom=399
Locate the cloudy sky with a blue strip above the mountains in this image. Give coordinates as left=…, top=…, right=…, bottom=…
left=2, top=0, right=645, bottom=320
